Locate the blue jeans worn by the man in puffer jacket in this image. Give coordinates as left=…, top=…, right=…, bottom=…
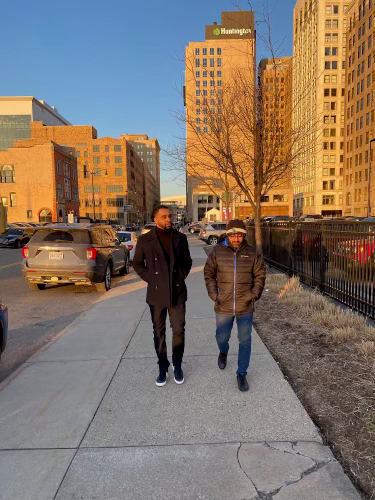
left=216, top=312, right=253, bottom=375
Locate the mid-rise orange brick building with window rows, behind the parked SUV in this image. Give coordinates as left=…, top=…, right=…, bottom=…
left=31, top=122, right=160, bottom=224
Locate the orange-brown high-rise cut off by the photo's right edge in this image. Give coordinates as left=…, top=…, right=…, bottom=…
left=344, top=0, right=375, bottom=217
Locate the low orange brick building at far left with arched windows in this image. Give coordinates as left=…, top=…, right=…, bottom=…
left=0, top=139, right=79, bottom=222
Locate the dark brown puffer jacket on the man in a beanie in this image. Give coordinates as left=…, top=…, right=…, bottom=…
left=204, top=240, right=266, bottom=315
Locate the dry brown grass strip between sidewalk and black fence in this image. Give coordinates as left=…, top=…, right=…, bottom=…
left=255, top=273, right=375, bottom=500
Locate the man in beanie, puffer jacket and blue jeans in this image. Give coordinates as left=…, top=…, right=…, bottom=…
left=204, top=220, right=266, bottom=391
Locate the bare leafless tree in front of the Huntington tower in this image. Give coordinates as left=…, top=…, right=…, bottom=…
left=168, top=8, right=324, bottom=253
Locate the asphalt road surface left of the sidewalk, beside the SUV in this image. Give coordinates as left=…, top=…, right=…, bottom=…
left=0, top=248, right=126, bottom=382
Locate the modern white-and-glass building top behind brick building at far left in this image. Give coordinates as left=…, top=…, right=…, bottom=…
left=0, top=96, right=70, bottom=151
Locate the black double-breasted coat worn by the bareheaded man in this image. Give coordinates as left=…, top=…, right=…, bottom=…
left=133, top=227, right=192, bottom=307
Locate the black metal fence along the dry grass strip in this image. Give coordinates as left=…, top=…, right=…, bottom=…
left=247, top=221, right=375, bottom=319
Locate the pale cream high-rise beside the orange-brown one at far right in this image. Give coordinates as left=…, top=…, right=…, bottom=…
left=292, top=0, right=349, bottom=216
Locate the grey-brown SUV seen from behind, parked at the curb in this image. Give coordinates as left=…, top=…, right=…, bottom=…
left=22, top=224, right=130, bottom=292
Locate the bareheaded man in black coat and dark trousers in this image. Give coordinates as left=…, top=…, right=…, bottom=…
left=133, top=205, right=192, bottom=387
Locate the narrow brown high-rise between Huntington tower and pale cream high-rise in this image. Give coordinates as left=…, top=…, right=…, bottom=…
left=258, top=56, right=293, bottom=218
